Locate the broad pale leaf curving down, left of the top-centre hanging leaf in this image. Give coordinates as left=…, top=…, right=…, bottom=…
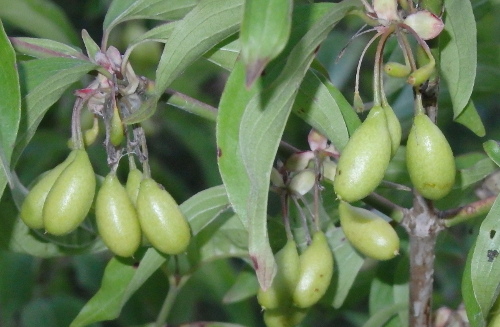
left=155, top=0, right=243, bottom=95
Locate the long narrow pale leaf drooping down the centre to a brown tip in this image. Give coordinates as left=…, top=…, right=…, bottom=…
left=239, top=1, right=357, bottom=288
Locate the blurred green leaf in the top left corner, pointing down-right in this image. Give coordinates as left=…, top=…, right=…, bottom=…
left=0, top=0, right=78, bottom=44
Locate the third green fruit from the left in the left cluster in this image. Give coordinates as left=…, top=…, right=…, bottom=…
left=95, top=173, right=141, bottom=257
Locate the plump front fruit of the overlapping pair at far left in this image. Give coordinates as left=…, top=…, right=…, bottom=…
left=43, top=149, right=96, bottom=235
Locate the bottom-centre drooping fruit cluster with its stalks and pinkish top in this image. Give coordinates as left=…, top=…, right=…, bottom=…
left=257, top=130, right=336, bottom=327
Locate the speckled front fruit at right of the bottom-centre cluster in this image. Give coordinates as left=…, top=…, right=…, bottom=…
left=293, top=231, right=333, bottom=308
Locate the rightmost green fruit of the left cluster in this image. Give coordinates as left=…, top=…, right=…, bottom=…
left=137, top=178, right=191, bottom=254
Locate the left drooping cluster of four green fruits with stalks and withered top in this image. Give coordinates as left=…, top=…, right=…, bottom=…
left=20, top=47, right=191, bottom=257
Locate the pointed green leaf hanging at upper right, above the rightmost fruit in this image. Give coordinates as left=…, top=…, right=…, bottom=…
left=440, top=0, right=477, bottom=118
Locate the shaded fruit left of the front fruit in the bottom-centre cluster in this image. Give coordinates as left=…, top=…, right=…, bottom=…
left=257, top=239, right=300, bottom=310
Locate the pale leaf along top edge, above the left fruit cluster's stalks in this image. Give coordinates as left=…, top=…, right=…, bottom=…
left=103, top=0, right=199, bottom=34
